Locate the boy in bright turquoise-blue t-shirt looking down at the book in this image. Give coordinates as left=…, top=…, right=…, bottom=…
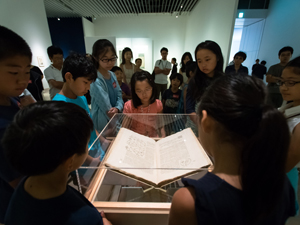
left=52, top=54, right=105, bottom=162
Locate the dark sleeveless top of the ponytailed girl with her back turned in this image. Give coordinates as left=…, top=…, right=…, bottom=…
left=182, top=172, right=296, bottom=225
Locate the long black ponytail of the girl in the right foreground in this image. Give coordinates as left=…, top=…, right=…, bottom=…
left=241, top=105, right=289, bottom=222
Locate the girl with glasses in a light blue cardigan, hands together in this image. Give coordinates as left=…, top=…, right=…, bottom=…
left=90, top=39, right=124, bottom=132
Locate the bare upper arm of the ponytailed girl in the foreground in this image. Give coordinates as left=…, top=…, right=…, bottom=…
left=168, top=187, right=197, bottom=225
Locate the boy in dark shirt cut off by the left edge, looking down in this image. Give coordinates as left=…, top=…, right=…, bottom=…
left=0, top=26, right=32, bottom=224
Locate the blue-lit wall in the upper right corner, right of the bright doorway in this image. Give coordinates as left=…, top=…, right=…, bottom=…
left=258, top=0, right=300, bottom=67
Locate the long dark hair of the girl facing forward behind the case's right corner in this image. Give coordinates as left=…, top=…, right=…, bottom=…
left=189, top=41, right=224, bottom=101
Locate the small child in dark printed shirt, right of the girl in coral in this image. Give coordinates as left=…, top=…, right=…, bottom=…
left=162, top=73, right=183, bottom=113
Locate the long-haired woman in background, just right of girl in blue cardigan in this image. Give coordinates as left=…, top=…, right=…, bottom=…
left=120, top=47, right=136, bottom=85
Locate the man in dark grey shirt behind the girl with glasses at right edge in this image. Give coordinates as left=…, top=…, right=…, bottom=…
left=266, top=46, right=294, bottom=108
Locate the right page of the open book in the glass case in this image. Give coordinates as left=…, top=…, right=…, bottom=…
left=157, top=128, right=212, bottom=185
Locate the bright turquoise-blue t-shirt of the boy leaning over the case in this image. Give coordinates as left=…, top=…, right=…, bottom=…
left=52, top=94, right=105, bottom=160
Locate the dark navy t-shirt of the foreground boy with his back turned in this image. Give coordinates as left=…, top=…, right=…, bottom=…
left=5, top=179, right=103, bottom=225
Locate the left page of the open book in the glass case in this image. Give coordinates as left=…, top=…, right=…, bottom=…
left=105, top=128, right=157, bottom=183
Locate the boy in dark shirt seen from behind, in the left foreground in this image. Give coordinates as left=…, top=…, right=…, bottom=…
left=3, top=101, right=108, bottom=225
